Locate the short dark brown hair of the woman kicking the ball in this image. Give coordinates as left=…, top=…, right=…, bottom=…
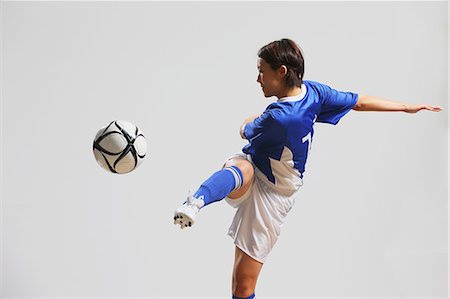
left=258, top=38, right=305, bottom=87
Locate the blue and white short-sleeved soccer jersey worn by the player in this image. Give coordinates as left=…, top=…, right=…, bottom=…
left=242, top=80, right=358, bottom=191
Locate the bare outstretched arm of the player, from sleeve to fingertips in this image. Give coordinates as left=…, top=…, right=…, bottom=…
left=353, top=95, right=442, bottom=113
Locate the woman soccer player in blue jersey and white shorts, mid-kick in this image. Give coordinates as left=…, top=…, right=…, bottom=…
left=174, top=39, right=442, bottom=299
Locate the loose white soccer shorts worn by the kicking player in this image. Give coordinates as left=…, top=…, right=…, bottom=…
left=225, top=154, right=297, bottom=263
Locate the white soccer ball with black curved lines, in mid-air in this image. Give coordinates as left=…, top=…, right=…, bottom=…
left=93, top=120, right=147, bottom=173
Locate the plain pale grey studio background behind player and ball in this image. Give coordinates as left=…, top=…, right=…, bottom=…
left=1, top=2, right=448, bottom=298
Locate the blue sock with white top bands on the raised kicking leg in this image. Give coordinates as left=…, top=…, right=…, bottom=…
left=194, top=166, right=244, bottom=206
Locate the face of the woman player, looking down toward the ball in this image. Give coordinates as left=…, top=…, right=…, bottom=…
left=256, top=58, right=286, bottom=98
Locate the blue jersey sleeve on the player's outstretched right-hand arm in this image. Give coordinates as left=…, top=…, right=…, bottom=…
left=316, top=83, right=358, bottom=125
